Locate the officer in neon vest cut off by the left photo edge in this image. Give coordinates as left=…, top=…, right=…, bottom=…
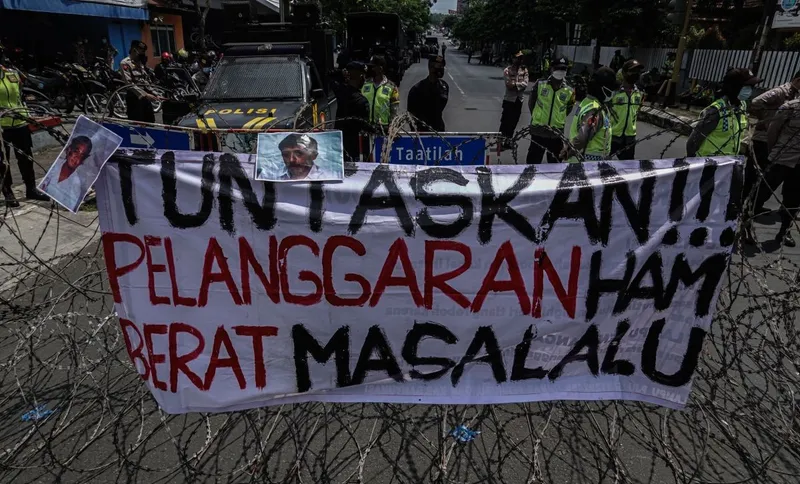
left=0, top=45, right=50, bottom=208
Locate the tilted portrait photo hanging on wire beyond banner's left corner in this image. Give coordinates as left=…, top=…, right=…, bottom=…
left=39, top=116, right=121, bottom=213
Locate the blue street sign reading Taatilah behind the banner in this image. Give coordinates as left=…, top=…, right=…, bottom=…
left=375, top=136, right=486, bottom=166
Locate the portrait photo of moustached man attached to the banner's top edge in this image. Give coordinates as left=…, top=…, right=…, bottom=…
left=256, top=131, right=344, bottom=182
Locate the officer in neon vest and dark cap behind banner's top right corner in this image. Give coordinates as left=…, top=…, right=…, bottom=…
left=686, top=68, right=761, bottom=157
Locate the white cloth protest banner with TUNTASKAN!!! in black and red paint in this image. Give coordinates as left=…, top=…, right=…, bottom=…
left=96, top=150, right=741, bottom=413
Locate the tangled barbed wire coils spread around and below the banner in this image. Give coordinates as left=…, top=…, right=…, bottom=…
left=0, top=100, right=800, bottom=484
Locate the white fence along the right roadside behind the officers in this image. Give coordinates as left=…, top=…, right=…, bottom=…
left=556, top=45, right=800, bottom=89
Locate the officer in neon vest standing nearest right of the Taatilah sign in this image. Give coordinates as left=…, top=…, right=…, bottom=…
left=526, top=57, right=575, bottom=164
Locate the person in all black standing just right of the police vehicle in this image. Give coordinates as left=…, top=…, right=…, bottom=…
left=334, top=61, right=369, bottom=161
